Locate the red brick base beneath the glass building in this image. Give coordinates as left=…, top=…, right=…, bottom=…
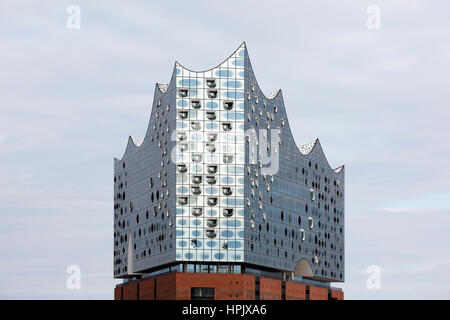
left=114, top=273, right=344, bottom=300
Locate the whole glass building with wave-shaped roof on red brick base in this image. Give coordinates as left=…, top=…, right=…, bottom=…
left=114, top=43, right=345, bottom=299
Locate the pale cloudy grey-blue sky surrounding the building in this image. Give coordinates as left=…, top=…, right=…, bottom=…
left=0, top=0, right=450, bottom=299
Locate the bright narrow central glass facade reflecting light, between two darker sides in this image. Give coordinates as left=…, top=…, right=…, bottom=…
left=176, top=48, right=245, bottom=262
